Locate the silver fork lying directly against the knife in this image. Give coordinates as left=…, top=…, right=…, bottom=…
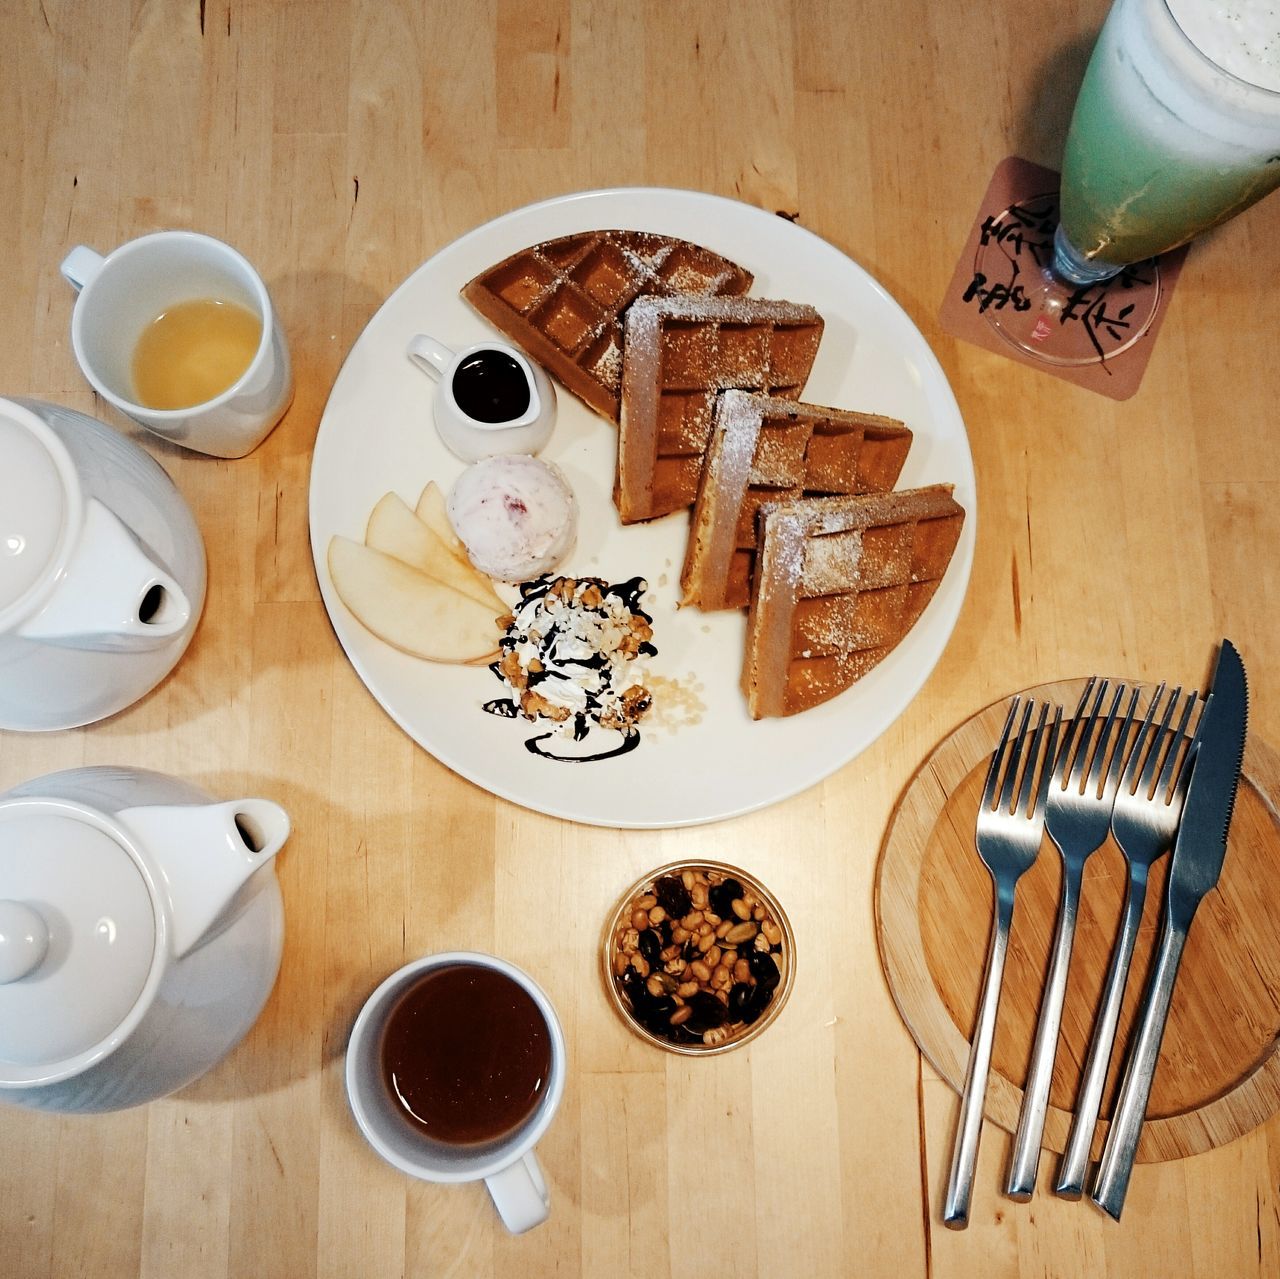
left=1055, top=684, right=1197, bottom=1200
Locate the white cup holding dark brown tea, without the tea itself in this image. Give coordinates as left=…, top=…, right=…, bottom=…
left=347, top=950, right=564, bottom=1234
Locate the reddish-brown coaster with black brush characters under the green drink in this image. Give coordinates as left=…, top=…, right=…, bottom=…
left=938, top=155, right=1187, bottom=399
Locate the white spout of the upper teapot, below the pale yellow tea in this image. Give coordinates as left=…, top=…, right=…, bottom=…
left=18, top=498, right=191, bottom=652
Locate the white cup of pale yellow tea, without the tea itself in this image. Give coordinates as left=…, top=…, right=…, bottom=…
left=61, top=230, right=293, bottom=457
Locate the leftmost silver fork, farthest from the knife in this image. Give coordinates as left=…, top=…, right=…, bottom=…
left=942, top=696, right=1062, bottom=1230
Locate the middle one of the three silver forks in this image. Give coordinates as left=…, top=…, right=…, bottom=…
left=1005, top=676, right=1137, bottom=1202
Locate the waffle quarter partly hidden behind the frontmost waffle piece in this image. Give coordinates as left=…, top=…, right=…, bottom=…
left=680, top=390, right=911, bottom=609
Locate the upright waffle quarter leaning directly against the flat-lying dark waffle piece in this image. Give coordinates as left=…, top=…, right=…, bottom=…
left=614, top=297, right=822, bottom=524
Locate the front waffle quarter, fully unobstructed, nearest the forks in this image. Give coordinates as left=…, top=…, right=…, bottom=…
left=742, top=484, right=964, bottom=720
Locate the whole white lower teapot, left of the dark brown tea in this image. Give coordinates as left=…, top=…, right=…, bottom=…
left=0, top=767, right=289, bottom=1113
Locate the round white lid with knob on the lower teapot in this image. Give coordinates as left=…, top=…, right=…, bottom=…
left=0, top=799, right=156, bottom=1084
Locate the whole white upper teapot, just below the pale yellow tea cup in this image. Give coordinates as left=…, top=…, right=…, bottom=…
left=0, top=399, right=205, bottom=730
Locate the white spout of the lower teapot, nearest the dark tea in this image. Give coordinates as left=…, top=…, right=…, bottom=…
left=118, top=799, right=289, bottom=959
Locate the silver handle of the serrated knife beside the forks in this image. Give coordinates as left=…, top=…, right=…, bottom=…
left=1089, top=921, right=1187, bottom=1221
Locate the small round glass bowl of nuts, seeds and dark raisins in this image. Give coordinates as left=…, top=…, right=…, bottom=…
left=600, top=862, right=795, bottom=1056
